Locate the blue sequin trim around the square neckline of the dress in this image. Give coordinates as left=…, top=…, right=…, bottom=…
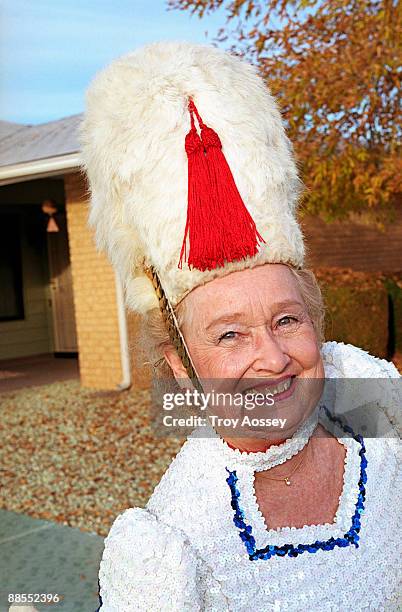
left=226, top=407, right=367, bottom=561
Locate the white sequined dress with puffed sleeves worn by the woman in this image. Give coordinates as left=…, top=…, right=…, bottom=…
left=99, top=342, right=402, bottom=612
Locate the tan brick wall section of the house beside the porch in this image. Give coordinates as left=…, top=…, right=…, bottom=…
left=65, top=174, right=123, bottom=389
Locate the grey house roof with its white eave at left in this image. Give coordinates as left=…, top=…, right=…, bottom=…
left=0, top=114, right=82, bottom=185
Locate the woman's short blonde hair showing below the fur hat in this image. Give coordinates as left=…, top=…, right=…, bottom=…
left=140, top=264, right=325, bottom=378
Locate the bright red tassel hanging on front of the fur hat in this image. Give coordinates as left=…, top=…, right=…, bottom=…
left=179, top=101, right=265, bottom=271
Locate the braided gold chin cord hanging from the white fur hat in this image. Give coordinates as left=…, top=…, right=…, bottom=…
left=144, top=266, right=202, bottom=393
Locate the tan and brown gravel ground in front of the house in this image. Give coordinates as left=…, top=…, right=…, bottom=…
left=0, top=381, right=183, bottom=536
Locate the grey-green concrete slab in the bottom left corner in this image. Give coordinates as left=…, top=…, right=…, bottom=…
left=0, top=510, right=103, bottom=612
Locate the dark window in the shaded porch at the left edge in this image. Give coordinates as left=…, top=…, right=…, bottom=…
left=0, top=213, right=24, bottom=321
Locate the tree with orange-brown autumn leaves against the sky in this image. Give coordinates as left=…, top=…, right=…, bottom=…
left=168, top=0, right=402, bottom=223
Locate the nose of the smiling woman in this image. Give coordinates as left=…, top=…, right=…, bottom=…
left=251, top=330, right=291, bottom=375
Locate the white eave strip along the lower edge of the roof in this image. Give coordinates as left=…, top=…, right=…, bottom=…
left=0, top=152, right=81, bottom=185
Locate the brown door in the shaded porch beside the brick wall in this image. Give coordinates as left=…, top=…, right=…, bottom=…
left=47, top=213, right=78, bottom=353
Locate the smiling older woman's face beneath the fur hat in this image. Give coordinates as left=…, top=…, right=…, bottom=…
left=167, top=264, right=324, bottom=439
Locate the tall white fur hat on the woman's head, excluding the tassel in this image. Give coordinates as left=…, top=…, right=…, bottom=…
left=81, top=42, right=304, bottom=313
